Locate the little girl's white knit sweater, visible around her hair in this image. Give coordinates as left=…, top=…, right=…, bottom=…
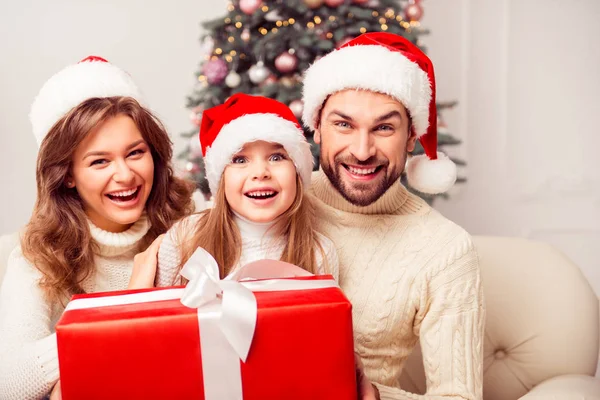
left=155, top=214, right=339, bottom=286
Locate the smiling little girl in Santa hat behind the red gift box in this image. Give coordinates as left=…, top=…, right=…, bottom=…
left=146, top=93, right=338, bottom=287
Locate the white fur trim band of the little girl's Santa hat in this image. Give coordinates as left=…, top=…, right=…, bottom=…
left=204, top=114, right=314, bottom=195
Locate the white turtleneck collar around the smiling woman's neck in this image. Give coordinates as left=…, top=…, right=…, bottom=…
left=88, top=213, right=150, bottom=256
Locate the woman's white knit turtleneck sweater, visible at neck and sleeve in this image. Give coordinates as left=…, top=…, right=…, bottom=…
left=0, top=216, right=150, bottom=400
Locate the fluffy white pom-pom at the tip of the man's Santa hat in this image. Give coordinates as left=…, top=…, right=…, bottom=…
left=406, top=152, right=456, bottom=194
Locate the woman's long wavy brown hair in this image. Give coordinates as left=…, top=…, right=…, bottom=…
left=21, top=97, right=193, bottom=302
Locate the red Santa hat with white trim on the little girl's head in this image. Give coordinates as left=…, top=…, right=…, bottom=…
left=200, top=93, right=313, bottom=194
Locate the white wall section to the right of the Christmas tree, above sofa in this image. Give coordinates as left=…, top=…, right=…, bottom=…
left=423, top=0, right=600, bottom=294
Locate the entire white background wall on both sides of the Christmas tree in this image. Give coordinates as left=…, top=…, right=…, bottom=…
left=0, top=0, right=600, bottom=293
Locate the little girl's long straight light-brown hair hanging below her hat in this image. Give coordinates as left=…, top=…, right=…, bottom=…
left=176, top=176, right=328, bottom=278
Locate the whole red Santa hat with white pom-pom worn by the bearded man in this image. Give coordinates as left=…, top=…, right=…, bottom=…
left=302, top=32, right=456, bottom=194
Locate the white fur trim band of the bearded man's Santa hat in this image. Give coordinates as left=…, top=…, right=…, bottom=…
left=302, top=45, right=431, bottom=136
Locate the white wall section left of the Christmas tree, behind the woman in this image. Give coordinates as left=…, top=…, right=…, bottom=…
left=0, top=0, right=226, bottom=234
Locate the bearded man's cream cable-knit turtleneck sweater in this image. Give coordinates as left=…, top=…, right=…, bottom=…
left=311, top=171, right=485, bottom=399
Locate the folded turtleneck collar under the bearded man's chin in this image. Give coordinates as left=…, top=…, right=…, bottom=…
left=312, top=169, right=429, bottom=215
